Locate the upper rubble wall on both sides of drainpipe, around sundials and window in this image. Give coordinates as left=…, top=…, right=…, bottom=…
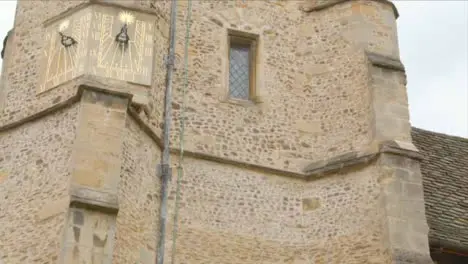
left=0, top=0, right=398, bottom=172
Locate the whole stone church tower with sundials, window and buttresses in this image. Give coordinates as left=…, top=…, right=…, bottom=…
left=0, top=0, right=431, bottom=264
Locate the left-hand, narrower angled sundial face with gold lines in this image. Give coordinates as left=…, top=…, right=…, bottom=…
left=39, top=10, right=91, bottom=92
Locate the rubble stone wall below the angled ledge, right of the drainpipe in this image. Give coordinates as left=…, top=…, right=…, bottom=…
left=162, top=158, right=390, bottom=264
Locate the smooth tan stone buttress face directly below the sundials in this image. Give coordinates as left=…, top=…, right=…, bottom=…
left=72, top=90, right=128, bottom=193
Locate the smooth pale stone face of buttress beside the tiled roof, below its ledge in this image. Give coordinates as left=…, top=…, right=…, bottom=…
left=379, top=154, right=432, bottom=263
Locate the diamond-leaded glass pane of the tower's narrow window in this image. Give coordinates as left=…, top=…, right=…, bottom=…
left=229, top=45, right=250, bottom=100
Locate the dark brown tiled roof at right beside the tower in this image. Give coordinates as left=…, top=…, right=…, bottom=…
left=412, top=128, right=468, bottom=251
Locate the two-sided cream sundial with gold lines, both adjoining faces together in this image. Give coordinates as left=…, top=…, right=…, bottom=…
left=39, top=5, right=156, bottom=92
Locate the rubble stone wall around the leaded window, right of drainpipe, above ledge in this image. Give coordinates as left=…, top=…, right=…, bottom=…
left=172, top=1, right=398, bottom=171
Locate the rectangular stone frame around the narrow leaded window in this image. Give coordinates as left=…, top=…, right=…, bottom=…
left=226, top=29, right=259, bottom=104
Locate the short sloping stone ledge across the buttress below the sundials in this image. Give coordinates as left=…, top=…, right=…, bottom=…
left=70, top=185, right=119, bottom=213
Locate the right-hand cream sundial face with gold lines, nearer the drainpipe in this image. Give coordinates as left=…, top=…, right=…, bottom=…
left=90, top=6, right=154, bottom=85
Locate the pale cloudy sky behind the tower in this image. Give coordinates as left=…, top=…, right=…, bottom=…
left=0, top=0, right=468, bottom=138
